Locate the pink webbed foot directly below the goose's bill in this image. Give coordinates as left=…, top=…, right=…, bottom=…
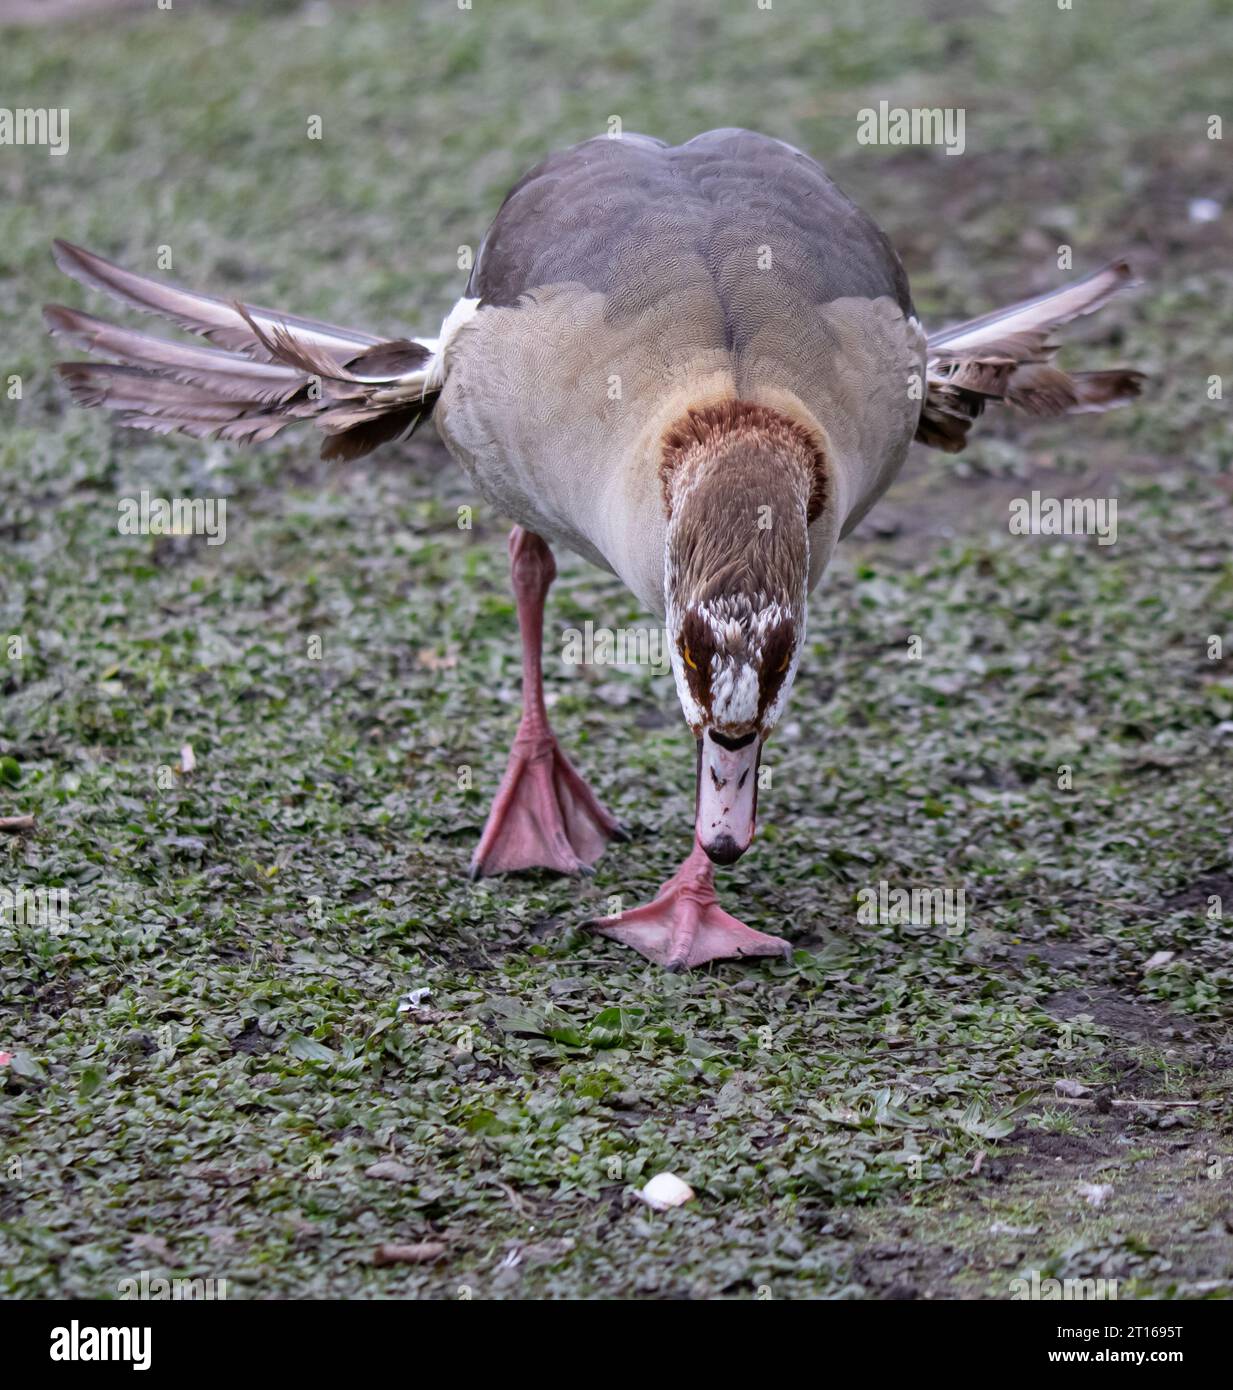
left=589, top=838, right=792, bottom=970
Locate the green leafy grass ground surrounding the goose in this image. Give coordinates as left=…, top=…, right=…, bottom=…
left=0, top=0, right=1233, bottom=1298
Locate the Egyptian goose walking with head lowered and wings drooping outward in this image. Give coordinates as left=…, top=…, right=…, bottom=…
left=46, top=131, right=1141, bottom=969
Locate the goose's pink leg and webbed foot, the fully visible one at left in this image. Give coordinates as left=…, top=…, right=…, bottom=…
left=471, top=525, right=624, bottom=878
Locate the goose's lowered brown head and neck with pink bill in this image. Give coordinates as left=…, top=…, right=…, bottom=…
left=664, top=402, right=820, bottom=865
